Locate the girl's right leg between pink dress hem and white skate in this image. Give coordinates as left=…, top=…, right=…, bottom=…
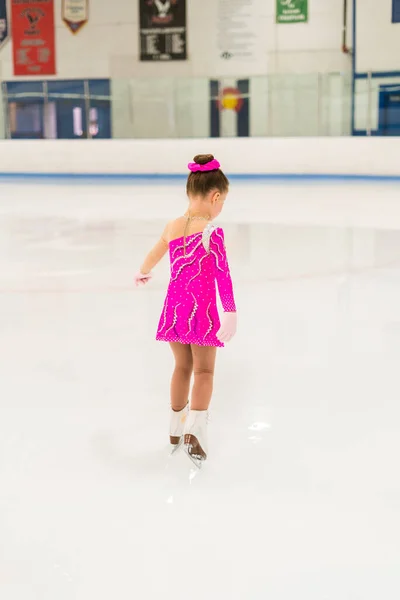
left=190, top=344, right=217, bottom=410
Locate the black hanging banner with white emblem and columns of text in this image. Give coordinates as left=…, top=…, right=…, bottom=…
left=139, top=0, right=187, bottom=61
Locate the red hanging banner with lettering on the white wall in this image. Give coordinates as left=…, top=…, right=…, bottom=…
left=11, top=0, right=56, bottom=75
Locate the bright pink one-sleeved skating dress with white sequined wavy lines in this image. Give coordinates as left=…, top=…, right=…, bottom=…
left=156, top=224, right=236, bottom=347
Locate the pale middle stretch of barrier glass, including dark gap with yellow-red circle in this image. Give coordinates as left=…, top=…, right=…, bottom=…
left=111, top=73, right=351, bottom=139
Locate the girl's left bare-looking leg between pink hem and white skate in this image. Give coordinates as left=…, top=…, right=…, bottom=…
left=170, top=342, right=193, bottom=412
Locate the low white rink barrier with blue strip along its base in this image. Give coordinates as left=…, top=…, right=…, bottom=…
left=0, top=137, right=400, bottom=181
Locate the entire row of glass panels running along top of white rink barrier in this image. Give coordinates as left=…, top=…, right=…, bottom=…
left=0, top=72, right=388, bottom=139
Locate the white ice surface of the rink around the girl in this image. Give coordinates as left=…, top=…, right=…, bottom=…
left=0, top=181, right=400, bottom=600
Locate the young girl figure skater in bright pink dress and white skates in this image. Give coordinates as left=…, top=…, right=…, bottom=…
left=135, top=154, right=236, bottom=467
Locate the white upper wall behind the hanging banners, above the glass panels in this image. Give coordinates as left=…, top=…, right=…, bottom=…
left=0, top=0, right=348, bottom=80
